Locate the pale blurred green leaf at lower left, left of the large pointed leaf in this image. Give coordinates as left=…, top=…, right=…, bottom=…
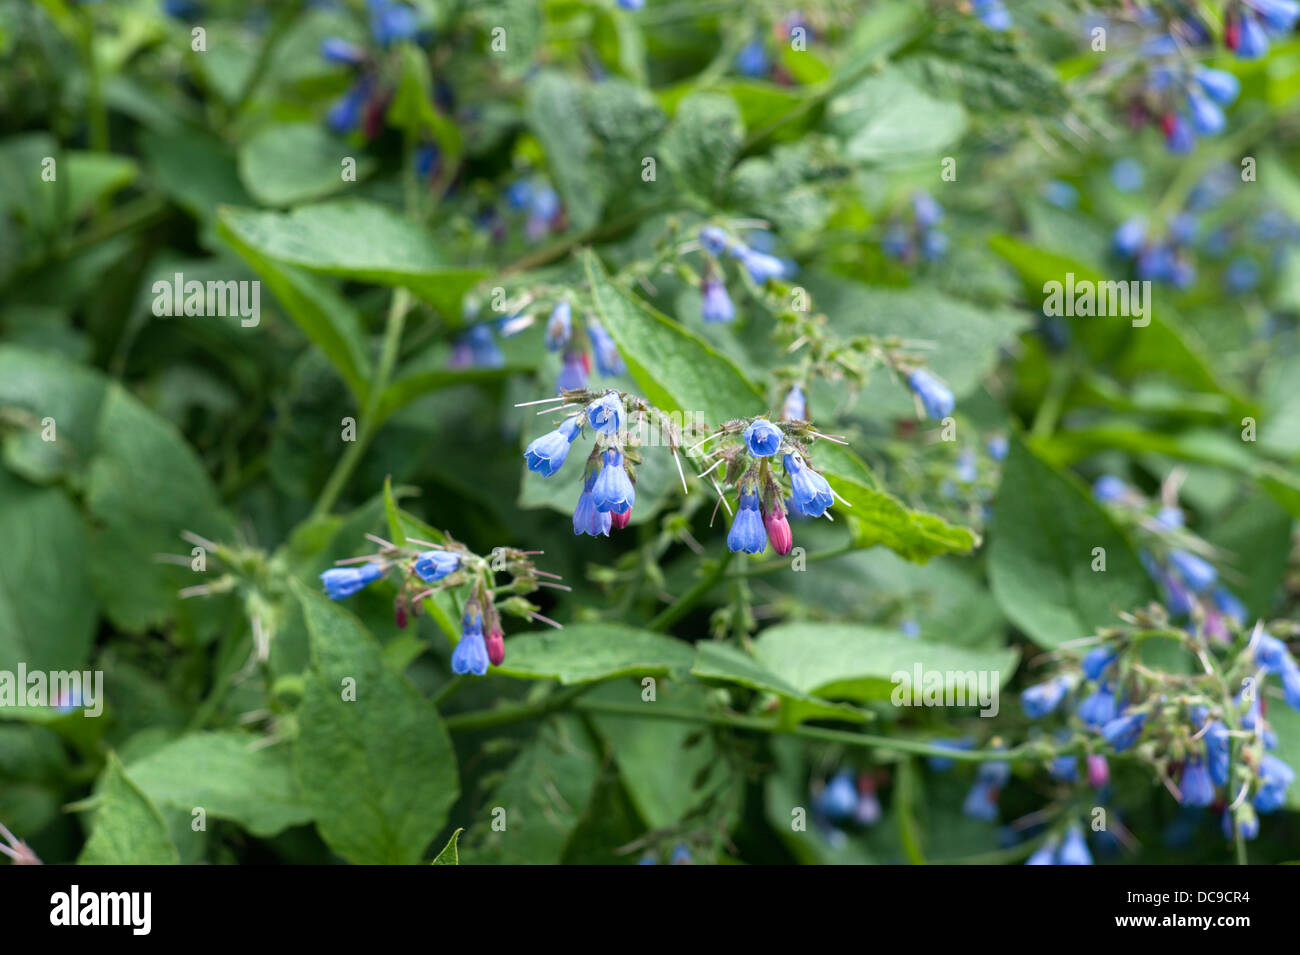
left=127, top=730, right=312, bottom=837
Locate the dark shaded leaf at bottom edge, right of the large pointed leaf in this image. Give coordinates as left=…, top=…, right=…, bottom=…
left=469, top=716, right=601, bottom=865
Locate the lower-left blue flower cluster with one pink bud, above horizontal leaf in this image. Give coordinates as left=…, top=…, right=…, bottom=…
left=321, top=535, right=563, bottom=677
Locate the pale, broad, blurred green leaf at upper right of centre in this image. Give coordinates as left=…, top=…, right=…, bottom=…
left=827, top=70, right=966, bottom=165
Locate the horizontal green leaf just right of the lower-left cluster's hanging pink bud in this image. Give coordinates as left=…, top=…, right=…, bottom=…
left=498, top=624, right=696, bottom=685
